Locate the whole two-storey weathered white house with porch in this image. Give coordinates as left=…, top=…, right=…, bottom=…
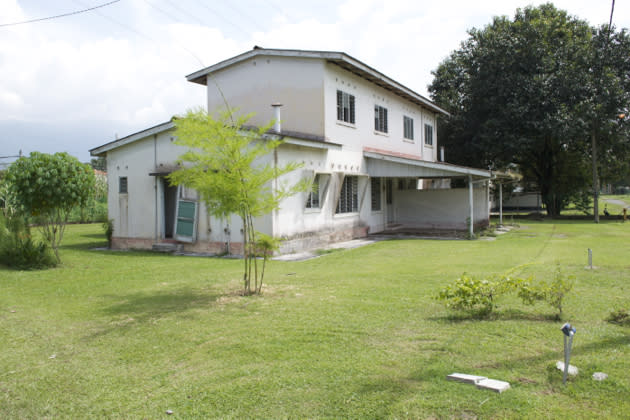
left=90, top=47, right=492, bottom=253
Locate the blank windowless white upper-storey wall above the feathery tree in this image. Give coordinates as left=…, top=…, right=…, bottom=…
left=207, top=56, right=324, bottom=136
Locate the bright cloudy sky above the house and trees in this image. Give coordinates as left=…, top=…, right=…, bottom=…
left=0, top=0, right=630, bottom=169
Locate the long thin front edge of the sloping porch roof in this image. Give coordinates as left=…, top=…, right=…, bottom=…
left=363, top=151, right=494, bottom=180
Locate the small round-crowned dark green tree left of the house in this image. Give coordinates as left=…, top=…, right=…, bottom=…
left=6, top=152, right=94, bottom=261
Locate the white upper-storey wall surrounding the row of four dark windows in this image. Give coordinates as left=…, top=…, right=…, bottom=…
left=324, top=63, right=437, bottom=161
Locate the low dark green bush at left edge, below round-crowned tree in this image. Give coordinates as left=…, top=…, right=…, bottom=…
left=0, top=216, right=57, bottom=270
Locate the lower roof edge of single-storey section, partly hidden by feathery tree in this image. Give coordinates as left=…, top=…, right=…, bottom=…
left=90, top=121, right=341, bottom=156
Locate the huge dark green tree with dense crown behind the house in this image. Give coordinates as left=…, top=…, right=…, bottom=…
left=429, top=4, right=625, bottom=216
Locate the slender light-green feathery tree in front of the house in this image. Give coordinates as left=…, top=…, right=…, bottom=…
left=169, top=110, right=308, bottom=294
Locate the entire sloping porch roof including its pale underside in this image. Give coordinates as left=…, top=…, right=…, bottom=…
left=363, top=150, right=494, bottom=180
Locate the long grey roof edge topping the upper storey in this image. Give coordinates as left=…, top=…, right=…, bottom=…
left=186, top=47, right=449, bottom=115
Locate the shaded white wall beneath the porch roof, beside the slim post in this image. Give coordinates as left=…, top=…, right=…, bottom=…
left=394, top=186, right=488, bottom=230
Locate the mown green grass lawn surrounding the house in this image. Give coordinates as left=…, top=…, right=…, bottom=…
left=0, top=221, right=630, bottom=419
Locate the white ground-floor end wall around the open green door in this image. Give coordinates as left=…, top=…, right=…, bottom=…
left=107, top=132, right=271, bottom=253
